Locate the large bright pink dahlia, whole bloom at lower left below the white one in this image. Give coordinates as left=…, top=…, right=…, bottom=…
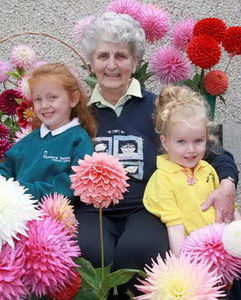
left=21, top=218, right=80, bottom=296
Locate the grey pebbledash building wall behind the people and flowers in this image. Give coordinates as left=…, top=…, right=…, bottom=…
left=0, top=0, right=241, bottom=202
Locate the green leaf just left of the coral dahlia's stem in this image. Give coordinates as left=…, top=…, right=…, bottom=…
left=75, top=257, right=101, bottom=291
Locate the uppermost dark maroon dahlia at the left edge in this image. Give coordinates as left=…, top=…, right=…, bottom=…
left=0, top=89, right=20, bottom=116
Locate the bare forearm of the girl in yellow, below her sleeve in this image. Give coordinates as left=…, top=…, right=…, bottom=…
left=167, top=224, right=185, bottom=255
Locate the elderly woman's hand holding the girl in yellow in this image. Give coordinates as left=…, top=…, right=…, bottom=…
left=201, top=179, right=236, bottom=223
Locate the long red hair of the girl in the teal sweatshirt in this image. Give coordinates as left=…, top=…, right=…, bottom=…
left=28, top=63, right=96, bottom=138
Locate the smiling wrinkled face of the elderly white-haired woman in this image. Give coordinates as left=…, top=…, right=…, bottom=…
left=91, top=41, right=138, bottom=96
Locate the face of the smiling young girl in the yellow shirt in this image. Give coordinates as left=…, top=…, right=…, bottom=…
left=160, top=120, right=207, bottom=168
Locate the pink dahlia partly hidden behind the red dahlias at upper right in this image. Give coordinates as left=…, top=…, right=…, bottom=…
left=171, top=20, right=195, bottom=51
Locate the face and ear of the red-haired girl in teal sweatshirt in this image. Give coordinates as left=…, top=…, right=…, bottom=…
left=32, top=77, right=79, bottom=130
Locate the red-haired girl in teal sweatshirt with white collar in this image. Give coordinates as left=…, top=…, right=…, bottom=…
left=0, top=63, right=96, bottom=200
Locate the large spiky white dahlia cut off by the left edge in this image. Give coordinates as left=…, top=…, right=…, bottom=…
left=0, top=176, right=40, bottom=250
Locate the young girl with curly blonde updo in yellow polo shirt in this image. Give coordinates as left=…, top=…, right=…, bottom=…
left=143, top=86, right=238, bottom=254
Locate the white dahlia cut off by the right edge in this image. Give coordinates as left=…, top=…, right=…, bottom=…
left=222, top=220, right=241, bottom=259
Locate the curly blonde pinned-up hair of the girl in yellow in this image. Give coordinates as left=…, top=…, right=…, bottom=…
left=155, top=86, right=216, bottom=142
